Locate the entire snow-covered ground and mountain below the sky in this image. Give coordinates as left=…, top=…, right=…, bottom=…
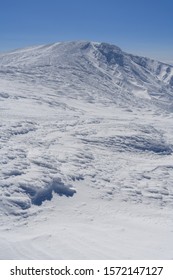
left=0, top=42, right=173, bottom=259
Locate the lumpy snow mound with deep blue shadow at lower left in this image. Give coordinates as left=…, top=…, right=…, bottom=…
left=0, top=178, right=76, bottom=215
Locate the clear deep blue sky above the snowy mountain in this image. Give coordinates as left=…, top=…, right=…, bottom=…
left=0, top=0, right=173, bottom=61
